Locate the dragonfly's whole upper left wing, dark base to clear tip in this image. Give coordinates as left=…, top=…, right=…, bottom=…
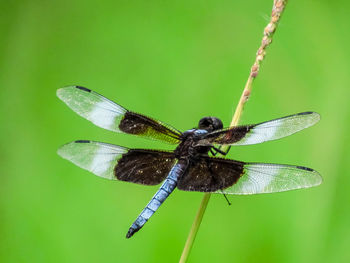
left=57, top=86, right=181, bottom=144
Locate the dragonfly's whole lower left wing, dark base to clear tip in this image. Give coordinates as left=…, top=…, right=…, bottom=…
left=58, top=140, right=175, bottom=185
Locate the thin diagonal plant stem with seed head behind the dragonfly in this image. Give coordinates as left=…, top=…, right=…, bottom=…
left=180, top=0, right=287, bottom=263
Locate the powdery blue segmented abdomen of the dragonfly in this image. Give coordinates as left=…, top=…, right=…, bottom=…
left=126, top=163, right=186, bottom=238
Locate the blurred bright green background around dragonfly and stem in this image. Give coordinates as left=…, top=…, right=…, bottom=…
left=0, top=0, right=350, bottom=262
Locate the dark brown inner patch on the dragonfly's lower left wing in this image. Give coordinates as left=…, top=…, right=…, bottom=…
left=114, top=149, right=175, bottom=185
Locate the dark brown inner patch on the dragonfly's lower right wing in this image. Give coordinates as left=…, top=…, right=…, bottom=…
left=177, top=157, right=244, bottom=192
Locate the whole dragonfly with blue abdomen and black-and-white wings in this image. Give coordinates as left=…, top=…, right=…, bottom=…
left=57, top=86, right=322, bottom=238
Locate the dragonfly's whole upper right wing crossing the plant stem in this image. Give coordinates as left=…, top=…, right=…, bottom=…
left=198, top=112, right=320, bottom=145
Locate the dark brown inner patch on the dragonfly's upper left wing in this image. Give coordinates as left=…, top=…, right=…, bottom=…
left=119, top=111, right=181, bottom=143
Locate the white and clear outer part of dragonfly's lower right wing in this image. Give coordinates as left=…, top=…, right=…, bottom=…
left=221, top=163, right=322, bottom=195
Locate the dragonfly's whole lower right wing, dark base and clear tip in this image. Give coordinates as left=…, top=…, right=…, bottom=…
left=178, top=157, right=322, bottom=195
